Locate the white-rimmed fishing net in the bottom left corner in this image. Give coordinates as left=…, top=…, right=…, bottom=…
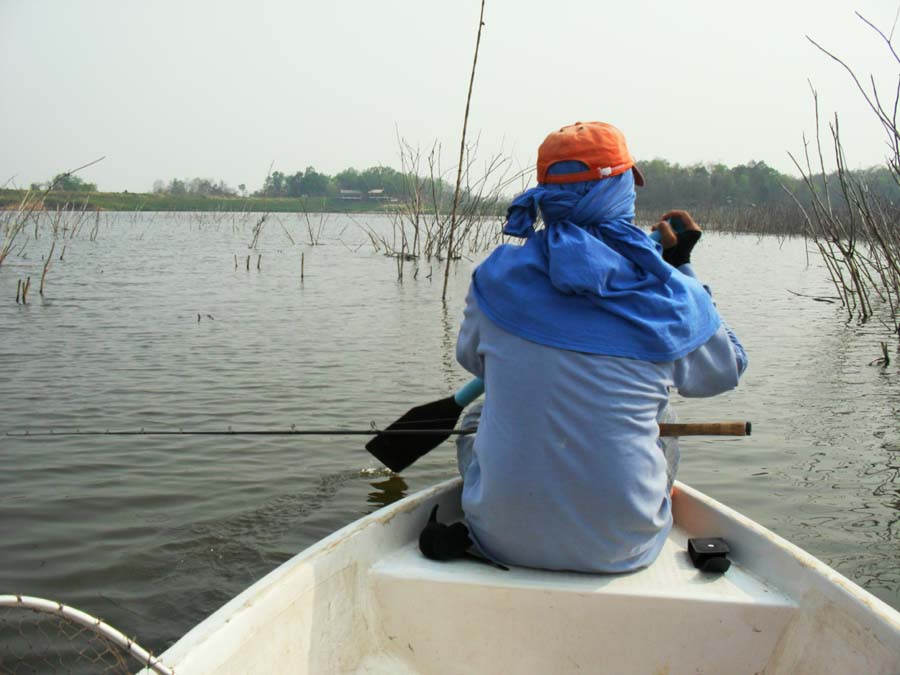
left=0, top=595, right=172, bottom=675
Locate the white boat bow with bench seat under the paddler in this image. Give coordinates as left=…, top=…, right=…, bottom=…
left=149, top=480, right=900, bottom=675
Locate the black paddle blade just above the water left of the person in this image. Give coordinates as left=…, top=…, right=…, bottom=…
left=366, top=396, right=463, bottom=472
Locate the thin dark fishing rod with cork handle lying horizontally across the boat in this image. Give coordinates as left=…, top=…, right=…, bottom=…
left=6, top=419, right=751, bottom=438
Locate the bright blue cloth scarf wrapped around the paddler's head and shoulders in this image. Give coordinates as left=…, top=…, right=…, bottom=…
left=472, top=171, right=721, bottom=362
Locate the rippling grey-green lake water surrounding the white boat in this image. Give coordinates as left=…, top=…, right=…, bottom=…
left=0, top=214, right=900, bottom=651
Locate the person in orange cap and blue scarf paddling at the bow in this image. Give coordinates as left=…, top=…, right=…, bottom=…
left=456, top=122, right=747, bottom=573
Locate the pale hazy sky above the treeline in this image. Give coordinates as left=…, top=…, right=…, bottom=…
left=0, top=0, right=900, bottom=191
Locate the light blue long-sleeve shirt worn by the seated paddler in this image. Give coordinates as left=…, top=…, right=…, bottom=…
left=456, top=265, right=747, bottom=572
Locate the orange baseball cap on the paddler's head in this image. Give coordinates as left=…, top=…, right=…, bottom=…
left=538, top=122, right=644, bottom=185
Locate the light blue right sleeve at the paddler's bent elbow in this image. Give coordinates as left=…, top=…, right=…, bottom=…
left=673, top=265, right=747, bottom=397
